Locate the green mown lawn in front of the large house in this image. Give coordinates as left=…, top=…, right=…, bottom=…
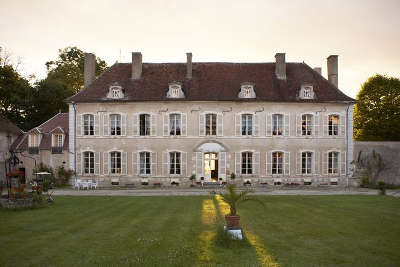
left=0, top=196, right=400, bottom=266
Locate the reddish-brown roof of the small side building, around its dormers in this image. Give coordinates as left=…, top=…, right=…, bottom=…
left=11, top=113, right=69, bottom=151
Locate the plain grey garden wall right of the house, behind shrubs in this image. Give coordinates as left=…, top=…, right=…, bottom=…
left=354, top=141, right=400, bottom=185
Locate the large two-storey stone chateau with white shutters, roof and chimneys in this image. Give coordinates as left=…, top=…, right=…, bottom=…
left=67, top=53, right=355, bottom=185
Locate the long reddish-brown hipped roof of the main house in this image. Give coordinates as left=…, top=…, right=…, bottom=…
left=66, top=63, right=355, bottom=102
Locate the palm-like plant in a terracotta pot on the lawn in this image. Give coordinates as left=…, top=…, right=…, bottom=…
left=220, top=184, right=263, bottom=229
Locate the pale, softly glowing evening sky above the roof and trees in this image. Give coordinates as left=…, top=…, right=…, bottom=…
left=0, top=0, right=400, bottom=97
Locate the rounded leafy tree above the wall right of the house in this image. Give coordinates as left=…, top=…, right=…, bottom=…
left=354, top=74, right=400, bottom=141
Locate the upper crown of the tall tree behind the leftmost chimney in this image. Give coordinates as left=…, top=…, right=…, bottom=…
left=46, top=46, right=107, bottom=93
